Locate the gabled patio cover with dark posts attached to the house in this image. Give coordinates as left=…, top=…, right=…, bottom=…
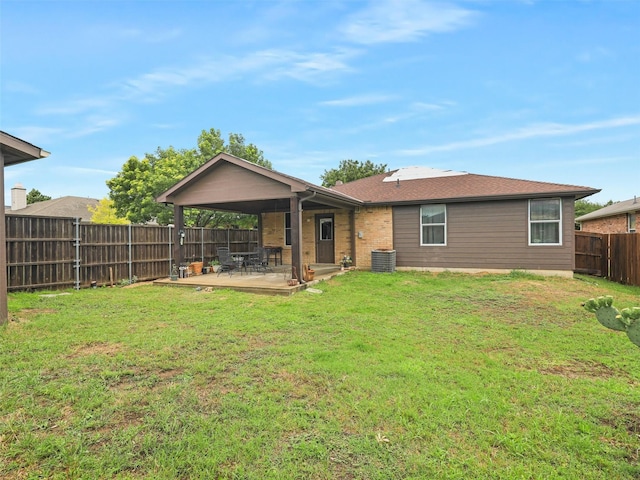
left=156, top=153, right=363, bottom=282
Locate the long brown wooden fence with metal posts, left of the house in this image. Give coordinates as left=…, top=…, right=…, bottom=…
left=5, top=215, right=258, bottom=290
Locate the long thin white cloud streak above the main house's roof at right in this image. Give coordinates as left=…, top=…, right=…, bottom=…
left=399, top=115, right=640, bottom=156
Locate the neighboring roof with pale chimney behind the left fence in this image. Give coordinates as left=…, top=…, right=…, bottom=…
left=5, top=183, right=100, bottom=222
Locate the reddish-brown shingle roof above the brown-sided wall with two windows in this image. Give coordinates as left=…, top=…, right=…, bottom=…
left=333, top=167, right=600, bottom=204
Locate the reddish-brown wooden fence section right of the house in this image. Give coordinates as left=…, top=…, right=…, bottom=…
left=575, top=232, right=640, bottom=285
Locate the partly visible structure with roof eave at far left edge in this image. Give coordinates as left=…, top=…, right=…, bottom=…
left=0, top=131, right=49, bottom=325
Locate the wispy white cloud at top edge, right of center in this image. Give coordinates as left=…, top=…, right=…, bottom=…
left=340, top=0, right=476, bottom=45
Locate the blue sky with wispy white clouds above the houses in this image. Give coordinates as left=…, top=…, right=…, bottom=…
left=0, top=0, right=640, bottom=204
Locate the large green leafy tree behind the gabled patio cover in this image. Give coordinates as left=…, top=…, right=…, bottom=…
left=107, top=128, right=272, bottom=228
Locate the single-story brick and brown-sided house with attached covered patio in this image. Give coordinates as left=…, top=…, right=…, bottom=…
left=156, top=153, right=599, bottom=276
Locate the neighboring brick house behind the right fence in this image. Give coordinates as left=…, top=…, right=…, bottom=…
left=576, top=197, right=640, bottom=233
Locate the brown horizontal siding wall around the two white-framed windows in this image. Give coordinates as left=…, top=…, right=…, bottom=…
left=393, top=198, right=574, bottom=270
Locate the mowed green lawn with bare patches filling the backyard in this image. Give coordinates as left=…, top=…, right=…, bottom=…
left=0, top=272, right=640, bottom=480
